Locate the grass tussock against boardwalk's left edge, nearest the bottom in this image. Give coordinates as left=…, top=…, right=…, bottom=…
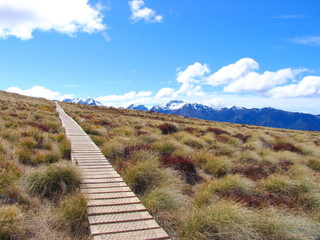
left=58, top=193, right=89, bottom=236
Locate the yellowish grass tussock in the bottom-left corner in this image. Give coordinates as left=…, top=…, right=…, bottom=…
left=0, top=205, right=26, bottom=240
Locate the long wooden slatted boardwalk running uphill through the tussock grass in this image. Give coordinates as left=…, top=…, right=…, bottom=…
left=57, top=103, right=169, bottom=240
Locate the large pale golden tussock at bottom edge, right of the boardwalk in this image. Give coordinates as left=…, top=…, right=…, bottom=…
left=180, top=200, right=257, bottom=240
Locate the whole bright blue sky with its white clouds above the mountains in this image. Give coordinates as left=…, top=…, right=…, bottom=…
left=0, top=0, right=320, bottom=114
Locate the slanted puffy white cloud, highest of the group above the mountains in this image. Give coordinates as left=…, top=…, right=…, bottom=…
left=207, top=58, right=259, bottom=86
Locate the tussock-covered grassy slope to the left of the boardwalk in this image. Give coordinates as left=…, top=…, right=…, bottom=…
left=0, top=91, right=88, bottom=240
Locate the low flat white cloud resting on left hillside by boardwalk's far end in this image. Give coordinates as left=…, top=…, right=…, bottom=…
left=6, top=86, right=73, bottom=100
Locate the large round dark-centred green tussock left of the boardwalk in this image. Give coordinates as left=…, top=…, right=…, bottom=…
left=27, top=164, right=81, bottom=200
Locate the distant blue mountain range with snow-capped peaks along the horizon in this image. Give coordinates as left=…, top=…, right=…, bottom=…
left=63, top=98, right=320, bottom=131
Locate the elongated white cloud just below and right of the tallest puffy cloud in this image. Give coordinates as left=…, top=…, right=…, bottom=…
left=224, top=68, right=302, bottom=93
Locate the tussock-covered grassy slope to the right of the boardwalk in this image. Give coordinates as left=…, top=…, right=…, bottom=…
left=62, top=103, right=320, bottom=240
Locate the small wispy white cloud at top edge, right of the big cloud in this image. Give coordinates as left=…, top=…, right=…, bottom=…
left=129, top=0, right=163, bottom=22
